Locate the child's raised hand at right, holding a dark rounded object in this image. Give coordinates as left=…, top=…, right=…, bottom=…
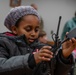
left=62, top=38, right=76, bottom=58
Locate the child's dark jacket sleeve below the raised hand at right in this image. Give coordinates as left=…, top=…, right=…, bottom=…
left=55, top=50, right=74, bottom=75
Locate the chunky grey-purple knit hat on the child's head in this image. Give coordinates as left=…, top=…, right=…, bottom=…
left=4, top=6, right=40, bottom=30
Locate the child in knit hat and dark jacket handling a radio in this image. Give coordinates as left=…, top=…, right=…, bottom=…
left=0, top=6, right=76, bottom=75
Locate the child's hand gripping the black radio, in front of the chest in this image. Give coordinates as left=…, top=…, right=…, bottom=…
left=34, top=46, right=53, bottom=64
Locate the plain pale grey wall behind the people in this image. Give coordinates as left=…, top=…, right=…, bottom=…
left=0, top=0, right=76, bottom=40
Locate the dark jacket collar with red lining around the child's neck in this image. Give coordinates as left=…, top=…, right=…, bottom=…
left=0, top=32, right=38, bottom=46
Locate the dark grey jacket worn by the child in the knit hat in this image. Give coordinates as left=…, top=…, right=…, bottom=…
left=0, top=34, right=73, bottom=75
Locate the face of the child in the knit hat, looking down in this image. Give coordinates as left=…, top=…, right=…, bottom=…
left=12, top=15, right=40, bottom=43
